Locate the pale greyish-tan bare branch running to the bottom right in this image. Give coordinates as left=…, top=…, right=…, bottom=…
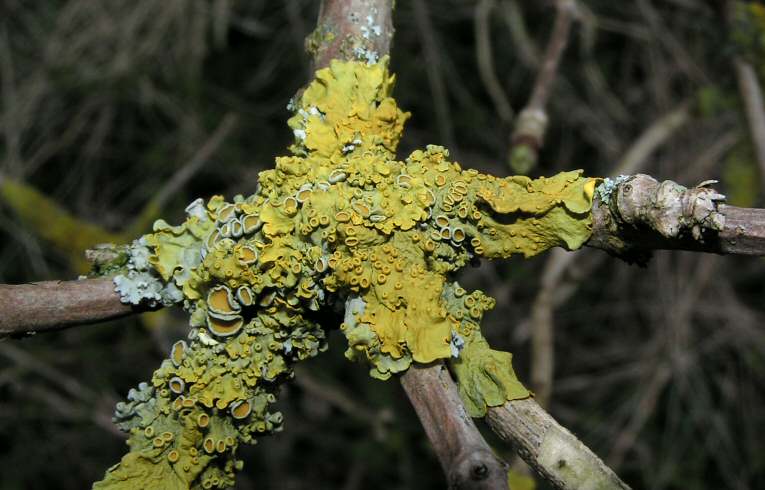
left=486, top=399, right=629, bottom=490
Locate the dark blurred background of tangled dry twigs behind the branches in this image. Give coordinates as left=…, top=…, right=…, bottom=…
left=0, top=0, right=765, bottom=490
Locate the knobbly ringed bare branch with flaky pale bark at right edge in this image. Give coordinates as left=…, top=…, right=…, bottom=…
left=587, top=174, right=765, bottom=262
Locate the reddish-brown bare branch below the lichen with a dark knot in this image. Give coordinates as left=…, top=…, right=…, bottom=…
left=401, top=362, right=507, bottom=490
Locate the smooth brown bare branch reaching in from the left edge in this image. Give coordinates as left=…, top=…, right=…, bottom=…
left=0, top=277, right=146, bottom=338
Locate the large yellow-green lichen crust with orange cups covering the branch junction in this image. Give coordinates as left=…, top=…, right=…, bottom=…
left=95, top=59, right=596, bottom=489
